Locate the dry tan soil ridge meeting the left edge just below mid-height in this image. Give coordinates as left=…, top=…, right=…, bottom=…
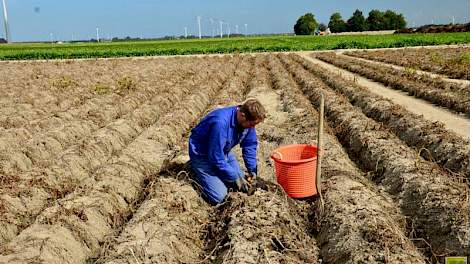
left=0, top=63, right=195, bottom=174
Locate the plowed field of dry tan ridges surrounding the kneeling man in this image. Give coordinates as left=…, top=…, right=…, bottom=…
left=0, top=50, right=470, bottom=263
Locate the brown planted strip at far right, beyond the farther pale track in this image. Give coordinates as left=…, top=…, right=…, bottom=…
left=346, top=46, right=470, bottom=80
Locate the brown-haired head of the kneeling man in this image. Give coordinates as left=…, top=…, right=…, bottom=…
left=237, top=99, right=266, bottom=128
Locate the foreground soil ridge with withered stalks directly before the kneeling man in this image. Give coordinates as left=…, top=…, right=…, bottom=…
left=210, top=190, right=320, bottom=263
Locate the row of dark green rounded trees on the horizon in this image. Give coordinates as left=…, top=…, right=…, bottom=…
left=294, top=9, right=406, bottom=35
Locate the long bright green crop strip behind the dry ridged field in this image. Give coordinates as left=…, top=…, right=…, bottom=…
left=0, top=32, right=470, bottom=60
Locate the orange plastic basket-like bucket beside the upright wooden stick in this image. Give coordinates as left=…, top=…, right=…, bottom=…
left=271, top=144, right=318, bottom=198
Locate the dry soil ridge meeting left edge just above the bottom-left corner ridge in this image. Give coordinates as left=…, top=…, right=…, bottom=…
left=0, top=56, right=229, bottom=244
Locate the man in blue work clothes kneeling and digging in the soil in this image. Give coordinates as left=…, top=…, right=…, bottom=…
left=189, top=99, right=266, bottom=205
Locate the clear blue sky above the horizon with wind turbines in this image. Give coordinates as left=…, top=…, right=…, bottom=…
left=0, top=0, right=470, bottom=41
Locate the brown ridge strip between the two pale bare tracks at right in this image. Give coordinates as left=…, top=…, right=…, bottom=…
left=315, top=52, right=470, bottom=116
